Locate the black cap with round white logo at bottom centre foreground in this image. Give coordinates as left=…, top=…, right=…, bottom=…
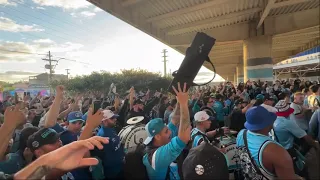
left=182, top=143, right=229, bottom=180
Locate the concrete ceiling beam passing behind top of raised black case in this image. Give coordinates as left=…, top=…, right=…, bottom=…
left=167, top=23, right=249, bottom=46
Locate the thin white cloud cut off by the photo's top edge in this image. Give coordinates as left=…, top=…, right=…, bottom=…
left=33, top=0, right=92, bottom=9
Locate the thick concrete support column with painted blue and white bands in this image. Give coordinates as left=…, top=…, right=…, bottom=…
left=243, top=36, right=273, bottom=82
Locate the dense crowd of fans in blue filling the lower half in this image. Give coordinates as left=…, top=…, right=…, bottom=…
left=0, top=79, right=320, bottom=180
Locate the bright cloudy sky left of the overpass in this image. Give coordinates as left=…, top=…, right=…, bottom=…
left=0, top=0, right=223, bottom=82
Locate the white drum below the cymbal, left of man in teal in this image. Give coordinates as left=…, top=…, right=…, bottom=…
left=118, top=124, right=148, bottom=150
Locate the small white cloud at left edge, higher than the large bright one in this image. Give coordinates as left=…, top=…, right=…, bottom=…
left=0, top=17, right=44, bottom=32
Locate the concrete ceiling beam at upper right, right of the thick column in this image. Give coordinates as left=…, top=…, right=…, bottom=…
left=264, top=7, right=320, bottom=35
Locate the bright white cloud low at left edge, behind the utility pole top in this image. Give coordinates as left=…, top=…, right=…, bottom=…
left=0, top=39, right=83, bottom=62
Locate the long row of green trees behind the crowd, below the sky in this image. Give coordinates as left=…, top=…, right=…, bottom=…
left=51, top=69, right=172, bottom=95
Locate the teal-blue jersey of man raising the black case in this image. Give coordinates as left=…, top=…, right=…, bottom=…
left=143, top=137, right=186, bottom=180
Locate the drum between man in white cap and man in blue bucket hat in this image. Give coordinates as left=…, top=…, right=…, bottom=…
left=219, top=136, right=239, bottom=171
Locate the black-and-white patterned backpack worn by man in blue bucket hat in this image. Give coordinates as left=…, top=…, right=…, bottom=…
left=235, top=130, right=268, bottom=180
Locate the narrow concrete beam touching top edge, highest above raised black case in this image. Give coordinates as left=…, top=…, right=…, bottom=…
left=147, top=0, right=234, bottom=22
